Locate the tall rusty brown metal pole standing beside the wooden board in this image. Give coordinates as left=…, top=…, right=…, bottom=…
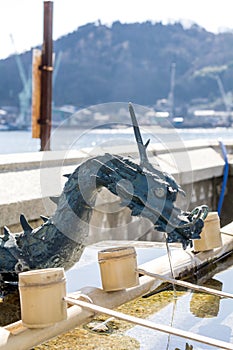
left=39, top=1, right=53, bottom=151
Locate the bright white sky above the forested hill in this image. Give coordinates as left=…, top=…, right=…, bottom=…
left=0, top=0, right=233, bottom=59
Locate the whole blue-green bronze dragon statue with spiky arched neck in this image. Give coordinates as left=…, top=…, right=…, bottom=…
left=0, top=104, right=208, bottom=279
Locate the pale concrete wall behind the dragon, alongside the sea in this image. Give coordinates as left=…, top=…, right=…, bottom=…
left=0, top=142, right=233, bottom=242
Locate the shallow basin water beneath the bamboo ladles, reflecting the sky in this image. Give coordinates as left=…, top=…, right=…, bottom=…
left=0, top=242, right=233, bottom=350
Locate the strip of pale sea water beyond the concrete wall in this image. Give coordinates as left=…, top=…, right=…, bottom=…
left=0, top=127, right=233, bottom=154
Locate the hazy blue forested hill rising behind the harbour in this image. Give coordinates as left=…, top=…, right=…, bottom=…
left=0, top=22, right=233, bottom=107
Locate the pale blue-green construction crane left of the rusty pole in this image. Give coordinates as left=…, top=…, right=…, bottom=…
left=10, top=34, right=32, bottom=129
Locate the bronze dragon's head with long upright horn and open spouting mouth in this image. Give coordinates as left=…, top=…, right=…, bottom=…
left=129, top=103, right=208, bottom=249
